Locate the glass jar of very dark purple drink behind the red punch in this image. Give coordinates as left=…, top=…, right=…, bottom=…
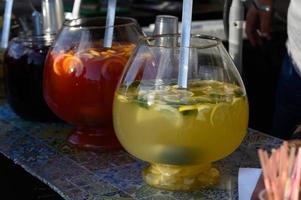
left=4, top=35, right=57, bottom=121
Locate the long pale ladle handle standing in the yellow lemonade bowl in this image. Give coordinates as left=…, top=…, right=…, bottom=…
left=178, top=0, right=193, bottom=88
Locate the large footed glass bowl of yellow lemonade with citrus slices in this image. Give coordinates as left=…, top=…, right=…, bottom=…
left=113, top=35, right=248, bottom=191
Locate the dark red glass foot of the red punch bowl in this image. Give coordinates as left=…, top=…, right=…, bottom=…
left=67, top=127, right=121, bottom=150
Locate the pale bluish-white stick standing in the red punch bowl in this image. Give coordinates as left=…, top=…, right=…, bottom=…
left=104, top=0, right=116, bottom=48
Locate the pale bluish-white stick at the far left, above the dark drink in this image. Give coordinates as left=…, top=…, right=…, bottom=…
left=1, top=0, right=14, bottom=49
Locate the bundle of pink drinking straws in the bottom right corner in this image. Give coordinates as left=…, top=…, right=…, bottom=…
left=258, top=142, right=301, bottom=200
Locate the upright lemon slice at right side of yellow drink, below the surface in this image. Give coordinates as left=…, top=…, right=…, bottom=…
left=210, top=103, right=231, bottom=126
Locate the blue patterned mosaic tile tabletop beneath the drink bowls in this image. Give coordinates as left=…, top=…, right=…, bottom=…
left=0, top=104, right=281, bottom=200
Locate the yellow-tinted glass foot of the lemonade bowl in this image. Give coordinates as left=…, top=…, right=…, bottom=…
left=143, top=164, right=219, bottom=191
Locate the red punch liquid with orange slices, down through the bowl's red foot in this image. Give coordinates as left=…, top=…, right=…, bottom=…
left=44, top=43, right=135, bottom=148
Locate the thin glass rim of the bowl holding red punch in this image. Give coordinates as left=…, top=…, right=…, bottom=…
left=63, top=17, right=138, bottom=29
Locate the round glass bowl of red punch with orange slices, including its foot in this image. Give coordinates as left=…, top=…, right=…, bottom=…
left=44, top=17, right=142, bottom=149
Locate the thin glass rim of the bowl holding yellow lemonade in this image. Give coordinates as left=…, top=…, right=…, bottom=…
left=140, top=34, right=222, bottom=49
